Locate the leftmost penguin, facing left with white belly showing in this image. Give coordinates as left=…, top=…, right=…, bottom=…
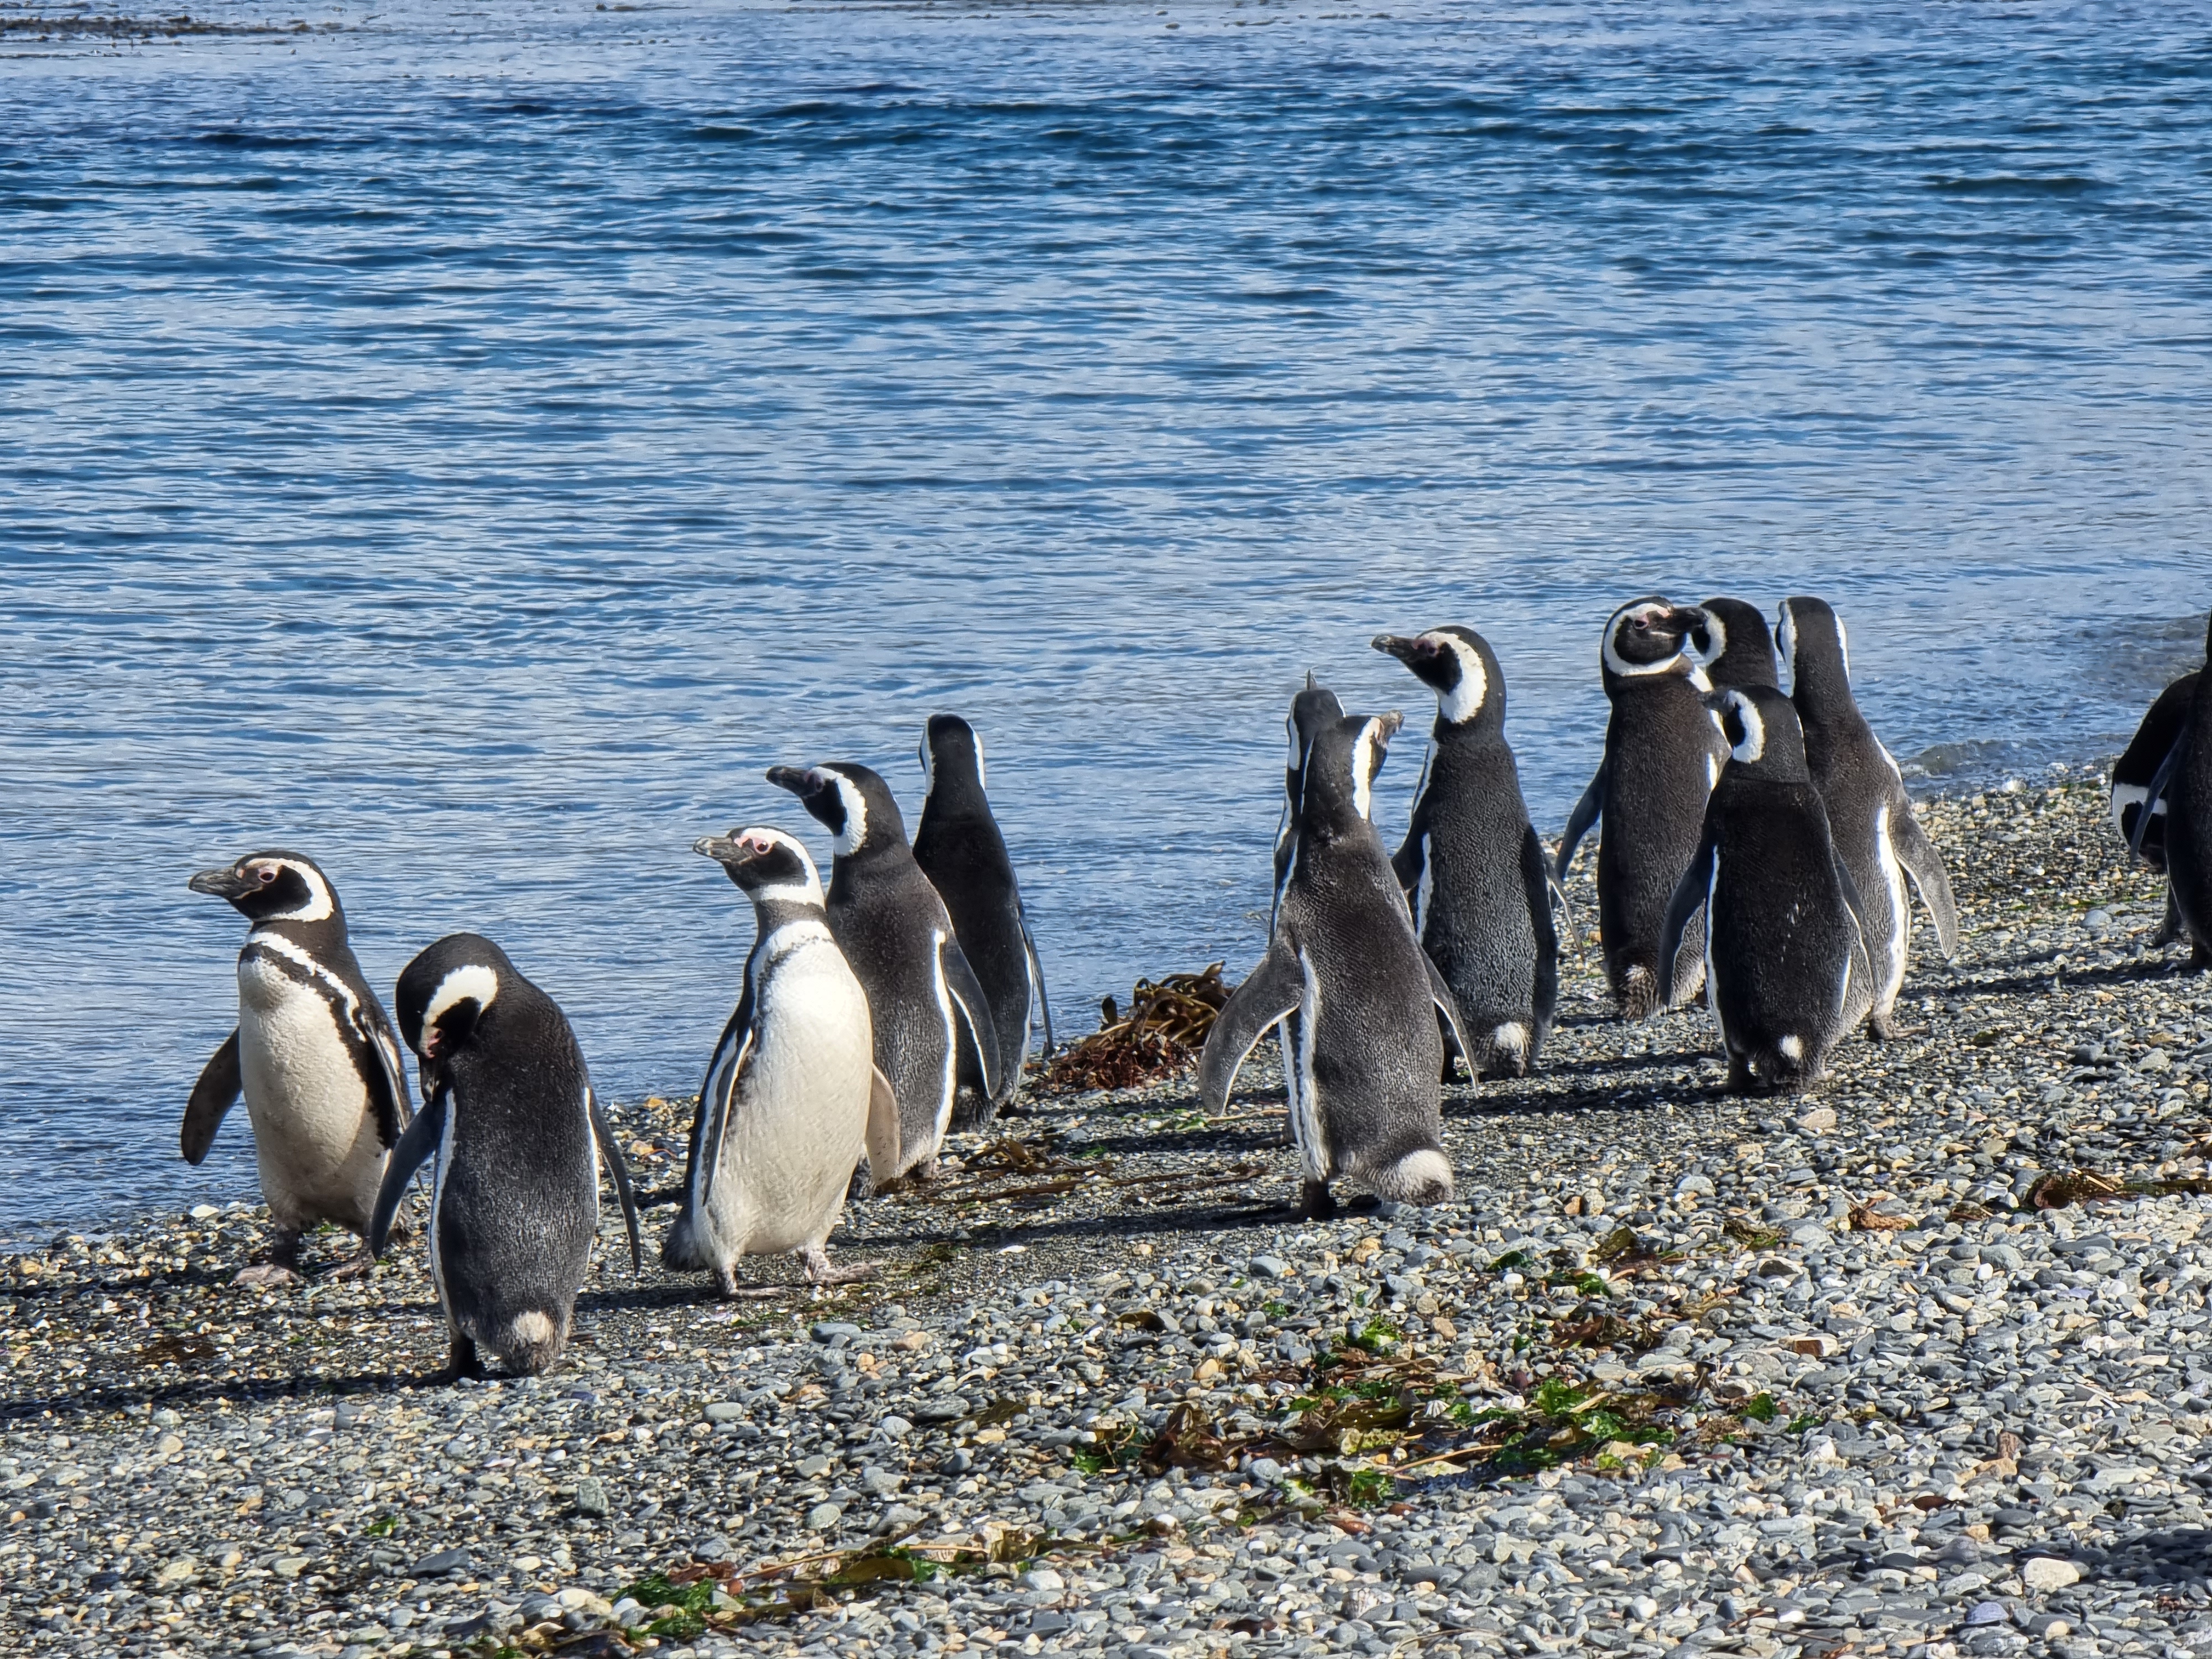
left=184, top=852, right=407, bottom=1285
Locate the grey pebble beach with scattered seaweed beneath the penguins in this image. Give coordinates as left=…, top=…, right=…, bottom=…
left=0, top=772, right=2212, bottom=1659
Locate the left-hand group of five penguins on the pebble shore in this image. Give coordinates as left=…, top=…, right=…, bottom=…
left=184, top=714, right=1051, bottom=1380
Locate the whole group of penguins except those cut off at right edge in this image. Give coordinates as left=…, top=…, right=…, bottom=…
left=184, top=597, right=1964, bottom=1378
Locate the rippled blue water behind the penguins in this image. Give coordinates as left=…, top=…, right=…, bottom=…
left=0, top=0, right=2212, bottom=1225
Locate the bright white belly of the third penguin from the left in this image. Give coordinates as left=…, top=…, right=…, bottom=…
left=708, top=949, right=874, bottom=1256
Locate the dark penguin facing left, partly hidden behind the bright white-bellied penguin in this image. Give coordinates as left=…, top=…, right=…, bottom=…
left=768, top=761, right=1000, bottom=1192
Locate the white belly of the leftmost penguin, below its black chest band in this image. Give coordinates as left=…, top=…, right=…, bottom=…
left=239, top=953, right=385, bottom=1232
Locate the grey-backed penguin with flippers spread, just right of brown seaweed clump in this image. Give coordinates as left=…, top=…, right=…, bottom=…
left=1199, top=714, right=1475, bottom=1217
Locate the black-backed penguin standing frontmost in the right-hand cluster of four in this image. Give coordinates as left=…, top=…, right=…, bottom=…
left=1659, top=686, right=1874, bottom=1095
